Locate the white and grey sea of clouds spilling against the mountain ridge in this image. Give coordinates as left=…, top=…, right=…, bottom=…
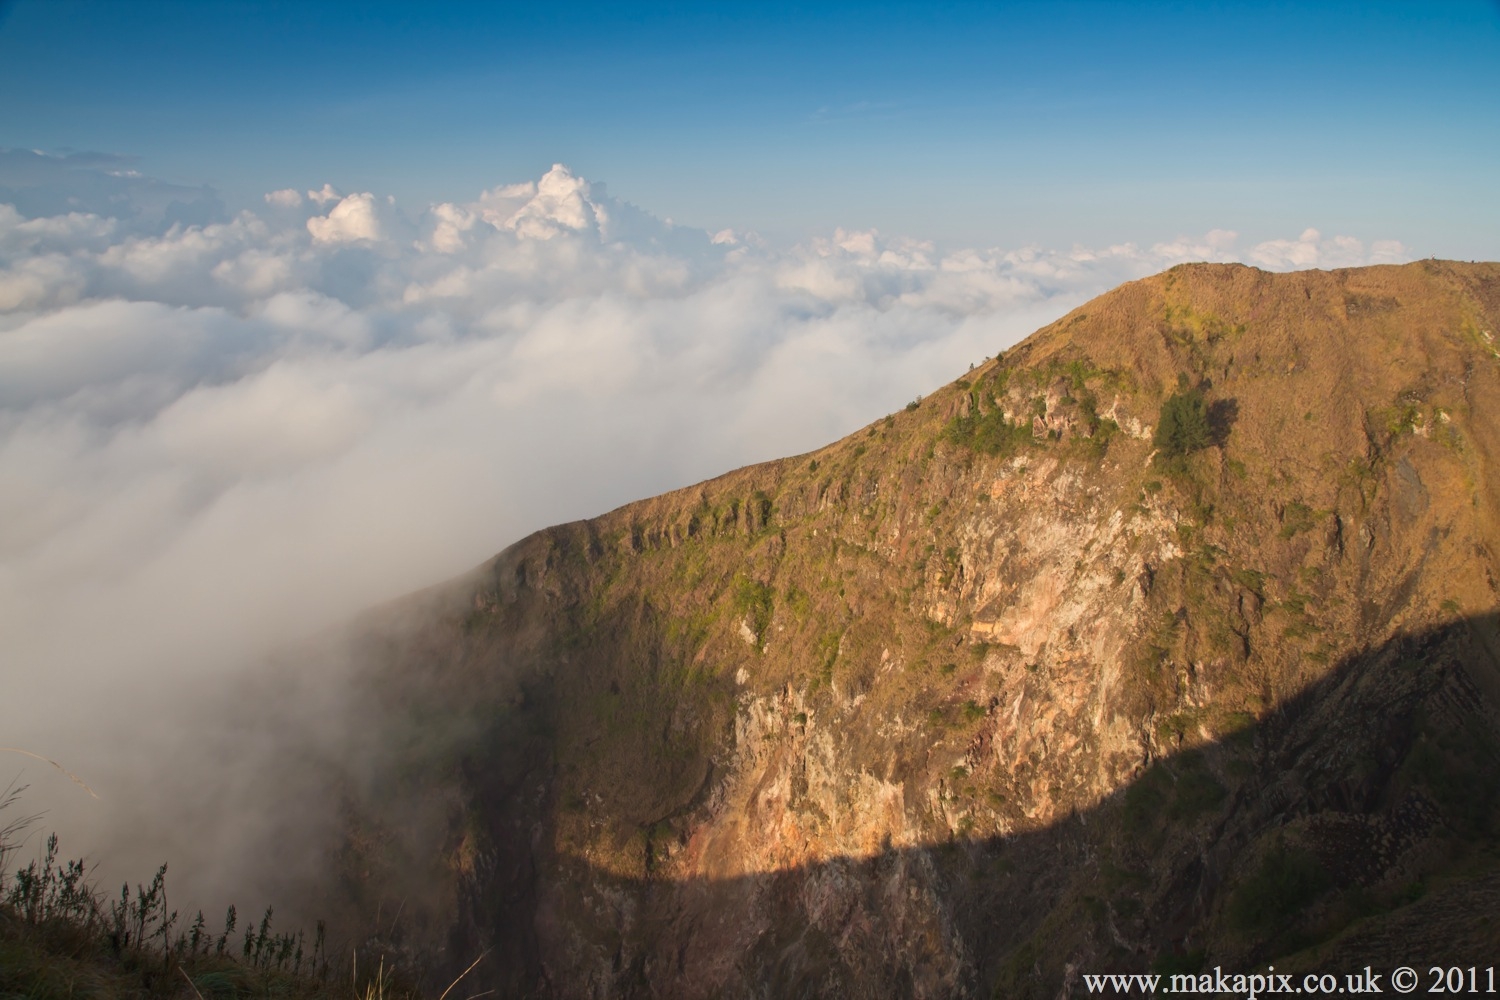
left=0, top=150, right=1406, bottom=923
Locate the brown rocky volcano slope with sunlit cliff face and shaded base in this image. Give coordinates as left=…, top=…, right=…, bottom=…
left=327, top=261, right=1500, bottom=997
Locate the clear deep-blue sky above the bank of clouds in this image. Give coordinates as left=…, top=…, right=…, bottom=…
left=0, top=0, right=1500, bottom=258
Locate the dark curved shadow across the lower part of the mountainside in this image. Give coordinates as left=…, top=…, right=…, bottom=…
left=420, top=613, right=1500, bottom=997
